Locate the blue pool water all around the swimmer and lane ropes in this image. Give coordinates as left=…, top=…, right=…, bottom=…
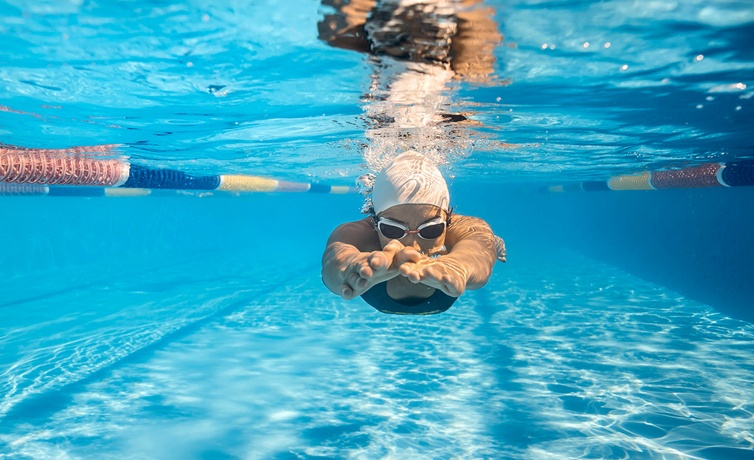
left=0, top=0, right=754, bottom=459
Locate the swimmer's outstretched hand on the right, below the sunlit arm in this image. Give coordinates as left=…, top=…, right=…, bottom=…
left=399, top=255, right=469, bottom=297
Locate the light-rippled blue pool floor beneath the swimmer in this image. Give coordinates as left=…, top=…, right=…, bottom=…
left=0, top=246, right=754, bottom=459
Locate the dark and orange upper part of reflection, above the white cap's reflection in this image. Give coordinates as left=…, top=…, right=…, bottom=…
left=318, top=0, right=502, bottom=82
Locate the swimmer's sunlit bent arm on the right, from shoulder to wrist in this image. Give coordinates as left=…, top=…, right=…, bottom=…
left=441, top=215, right=497, bottom=289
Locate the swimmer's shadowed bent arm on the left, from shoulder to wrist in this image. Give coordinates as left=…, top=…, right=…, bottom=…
left=322, top=218, right=380, bottom=298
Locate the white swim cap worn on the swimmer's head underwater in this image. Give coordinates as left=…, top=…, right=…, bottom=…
left=372, top=150, right=450, bottom=214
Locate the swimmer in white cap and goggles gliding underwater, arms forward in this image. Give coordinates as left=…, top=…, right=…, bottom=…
left=322, top=151, right=505, bottom=315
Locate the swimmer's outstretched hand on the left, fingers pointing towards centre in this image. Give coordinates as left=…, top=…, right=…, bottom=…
left=340, top=240, right=424, bottom=300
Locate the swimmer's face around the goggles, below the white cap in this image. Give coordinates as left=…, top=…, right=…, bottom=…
left=377, top=204, right=448, bottom=254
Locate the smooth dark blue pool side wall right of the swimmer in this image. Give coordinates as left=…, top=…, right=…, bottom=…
left=455, top=183, right=754, bottom=321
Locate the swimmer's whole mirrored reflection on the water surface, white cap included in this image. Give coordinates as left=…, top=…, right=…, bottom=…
left=318, top=0, right=504, bottom=162
